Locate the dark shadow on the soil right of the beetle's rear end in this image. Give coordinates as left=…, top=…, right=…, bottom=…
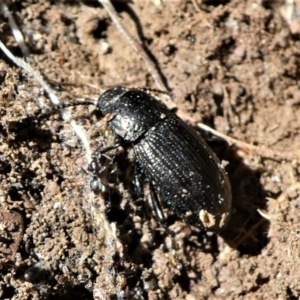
left=209, top=141, right=270, bottom=255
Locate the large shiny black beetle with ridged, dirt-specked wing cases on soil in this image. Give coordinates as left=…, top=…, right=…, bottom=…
left=90, top=86, right=231, bottom=231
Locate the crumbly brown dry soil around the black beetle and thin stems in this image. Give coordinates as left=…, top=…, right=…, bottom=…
left=0, top=0, right=300, bottom=300
